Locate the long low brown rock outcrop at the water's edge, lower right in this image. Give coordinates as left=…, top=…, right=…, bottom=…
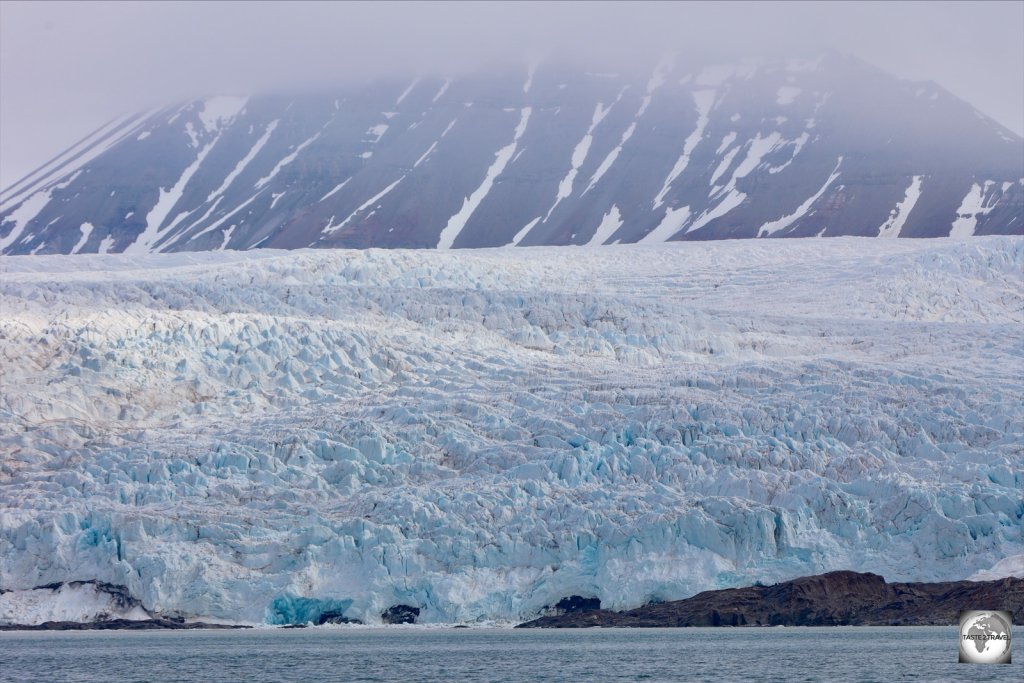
left=517, top=571, right=1024, bottom=629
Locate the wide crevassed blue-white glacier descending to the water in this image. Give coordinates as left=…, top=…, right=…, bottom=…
left=0, top=237, right=1024, bottom=624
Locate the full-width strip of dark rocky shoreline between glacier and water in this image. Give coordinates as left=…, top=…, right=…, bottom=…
left=0, top=571, right=1024, bottom=632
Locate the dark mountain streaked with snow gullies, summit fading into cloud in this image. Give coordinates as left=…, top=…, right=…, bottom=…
left=0, top=53, right=1024, bottom=254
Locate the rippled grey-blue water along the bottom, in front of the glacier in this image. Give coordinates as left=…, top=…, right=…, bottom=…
left=0, top=627, right=1024, bottom=683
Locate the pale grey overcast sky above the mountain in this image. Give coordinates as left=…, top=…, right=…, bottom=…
left=0, top=0, right=1024, bottom=187
